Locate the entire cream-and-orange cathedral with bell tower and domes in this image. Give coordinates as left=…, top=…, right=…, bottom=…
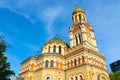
left=13, top=6, right=110, bottom=80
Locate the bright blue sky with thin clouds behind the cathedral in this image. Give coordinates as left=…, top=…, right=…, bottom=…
left=0, top=0, right=120, bottom=78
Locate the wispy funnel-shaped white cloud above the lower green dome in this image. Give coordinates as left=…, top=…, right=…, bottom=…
left=40, top=6, right=64, bottom=37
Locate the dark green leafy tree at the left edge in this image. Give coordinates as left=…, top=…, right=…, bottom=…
left=0, top=35, right=15, bottom=80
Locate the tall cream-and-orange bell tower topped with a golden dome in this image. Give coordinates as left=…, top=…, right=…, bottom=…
left=69, top=5, right=98, bottom=51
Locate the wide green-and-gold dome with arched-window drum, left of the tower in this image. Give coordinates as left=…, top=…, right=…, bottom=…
left=42, top=35, right=69, bottom=55
